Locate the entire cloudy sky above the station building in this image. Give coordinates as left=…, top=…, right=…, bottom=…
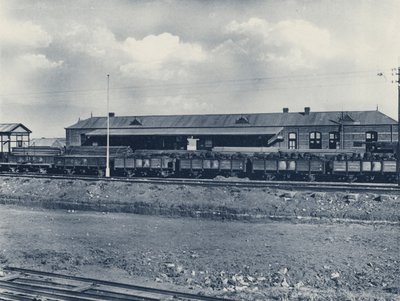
left=0, top=0, right=400, bottom=137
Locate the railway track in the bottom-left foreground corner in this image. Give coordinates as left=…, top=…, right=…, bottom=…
left=0, top=267, right=232, bottom=301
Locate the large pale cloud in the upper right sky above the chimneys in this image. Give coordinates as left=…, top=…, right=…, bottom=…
left=225, top=18, right=340, bottom=68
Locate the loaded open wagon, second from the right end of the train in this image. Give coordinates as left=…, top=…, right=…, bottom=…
left=250, top=157, right=325, bottom=180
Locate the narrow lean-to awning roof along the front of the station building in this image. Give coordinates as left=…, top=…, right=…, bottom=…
left=86, top=127, right=283, bottom=136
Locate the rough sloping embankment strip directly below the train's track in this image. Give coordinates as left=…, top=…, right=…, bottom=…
left=0, top=177, right=400, bottom=223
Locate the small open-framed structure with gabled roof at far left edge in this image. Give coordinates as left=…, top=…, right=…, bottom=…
left=0, top=123, right=32, bottom=153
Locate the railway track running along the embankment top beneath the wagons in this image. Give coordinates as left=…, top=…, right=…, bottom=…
left=0, top=173, right=400, bottom=194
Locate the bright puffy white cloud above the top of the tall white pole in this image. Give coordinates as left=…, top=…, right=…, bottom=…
left=62, top=22, right=207, bottom=80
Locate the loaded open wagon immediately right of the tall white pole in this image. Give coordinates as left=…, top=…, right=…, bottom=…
left=114, top=154, right=176, bottom=177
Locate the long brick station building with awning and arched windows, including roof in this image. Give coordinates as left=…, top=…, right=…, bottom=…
left=66, top=107, right=397, bottom=151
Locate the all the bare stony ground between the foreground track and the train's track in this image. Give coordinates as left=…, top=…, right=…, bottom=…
left=0, top=179, right=400, bottom=300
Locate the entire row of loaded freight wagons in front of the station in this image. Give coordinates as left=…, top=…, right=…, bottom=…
left=0, top=145, right=397, bottom=183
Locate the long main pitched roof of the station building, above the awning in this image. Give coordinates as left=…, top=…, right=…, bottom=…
left=68, top=111, right=396, bottom=129
